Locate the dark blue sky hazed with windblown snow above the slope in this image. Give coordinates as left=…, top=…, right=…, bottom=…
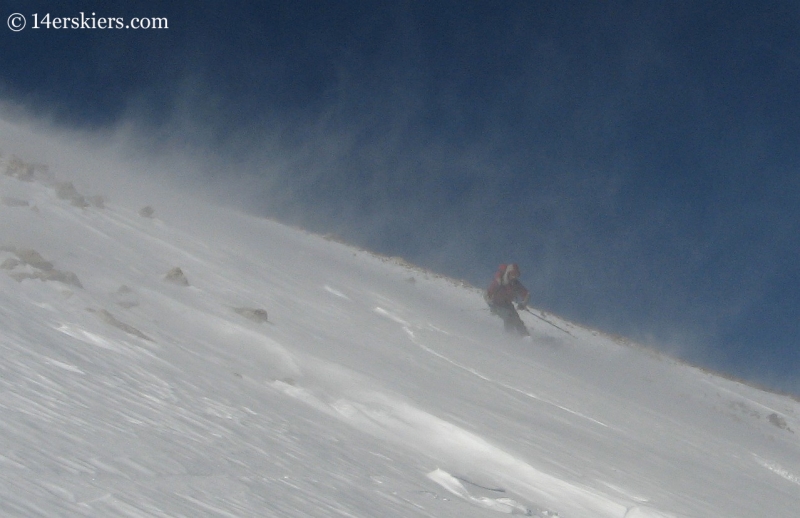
left=0, top=0, right=800, bottom=393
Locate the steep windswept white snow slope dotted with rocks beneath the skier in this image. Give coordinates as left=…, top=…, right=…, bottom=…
left=0, top=148, right=800, bottom=518
